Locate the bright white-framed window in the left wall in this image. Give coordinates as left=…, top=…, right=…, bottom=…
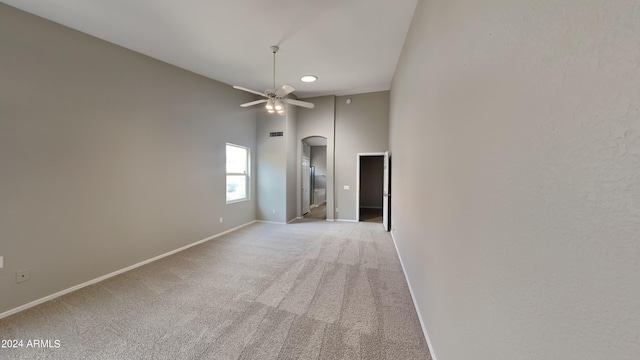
left=227, top=144, right=249, bottom=203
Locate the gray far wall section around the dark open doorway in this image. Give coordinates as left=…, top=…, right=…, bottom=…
left=335, top=91, right=389, bottom=220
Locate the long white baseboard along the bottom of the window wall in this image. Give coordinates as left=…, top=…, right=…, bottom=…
left=0, top=220, right=256, bottom=319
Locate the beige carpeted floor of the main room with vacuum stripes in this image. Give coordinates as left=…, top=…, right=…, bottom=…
left=0, top=220, right=430, bottom=360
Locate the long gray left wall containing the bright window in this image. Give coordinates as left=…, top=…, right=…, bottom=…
left=0, top=4, right=256, bottom=313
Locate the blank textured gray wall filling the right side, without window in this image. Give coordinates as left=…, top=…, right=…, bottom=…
left=390, top=0, right=640, bottom=360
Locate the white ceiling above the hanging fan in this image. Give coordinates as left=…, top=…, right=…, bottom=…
left=0, top=0, right=418, bottom=97
